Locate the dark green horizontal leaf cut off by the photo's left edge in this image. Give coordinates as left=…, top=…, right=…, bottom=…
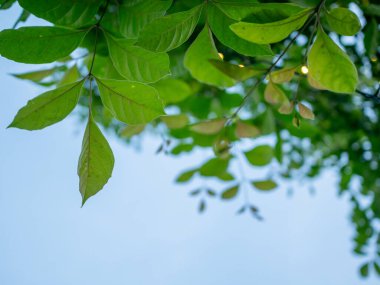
left=0, top=27, right=88, bottom=63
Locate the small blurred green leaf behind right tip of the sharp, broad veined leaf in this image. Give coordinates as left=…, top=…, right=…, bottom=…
left=152, top=78, right=193, bottom=104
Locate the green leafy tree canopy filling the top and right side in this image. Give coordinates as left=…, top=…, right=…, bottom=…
left=0, top=0, right=380, bottom=276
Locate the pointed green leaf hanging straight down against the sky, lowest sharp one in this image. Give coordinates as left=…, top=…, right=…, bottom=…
left=78, top=115, right=115, bottom=206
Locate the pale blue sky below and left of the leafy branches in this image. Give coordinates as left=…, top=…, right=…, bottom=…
left=0, top=2, right=379, bottom=285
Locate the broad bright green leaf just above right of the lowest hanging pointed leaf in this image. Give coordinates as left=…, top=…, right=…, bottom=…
left=96, top=78, right=165, bottom=125
